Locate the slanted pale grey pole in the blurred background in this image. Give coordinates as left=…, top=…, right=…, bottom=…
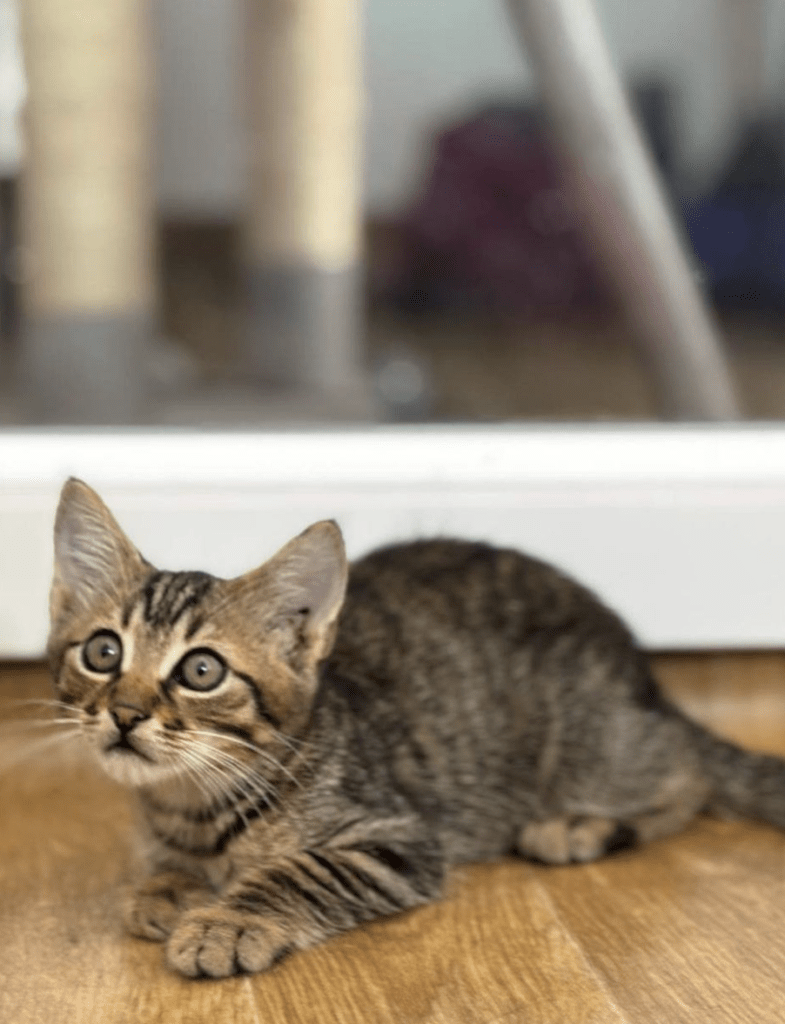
left=507, top=0, right=738, bottom=420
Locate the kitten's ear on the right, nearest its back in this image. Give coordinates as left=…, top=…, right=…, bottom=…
left=243, top=519, right=349, bottom=669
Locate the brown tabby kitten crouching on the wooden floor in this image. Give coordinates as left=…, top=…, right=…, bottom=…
left=48, top=479, right=785, bottom=977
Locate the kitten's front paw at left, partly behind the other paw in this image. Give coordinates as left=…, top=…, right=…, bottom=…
left=123, top=870, right=215, bottom=942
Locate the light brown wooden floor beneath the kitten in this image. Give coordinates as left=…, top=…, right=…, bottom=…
left=0, top=654, right=785, bottom=1024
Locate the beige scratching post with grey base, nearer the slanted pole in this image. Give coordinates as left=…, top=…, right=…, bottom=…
left=244, top=0, right=362, bottom=408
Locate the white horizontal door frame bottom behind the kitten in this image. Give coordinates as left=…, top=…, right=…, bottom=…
left=0, top=426, right=785, bottom=657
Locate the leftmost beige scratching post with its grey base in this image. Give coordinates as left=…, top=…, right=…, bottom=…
left=20, top=0, right=154, bottom=423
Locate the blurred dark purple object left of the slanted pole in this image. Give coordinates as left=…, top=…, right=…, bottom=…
left=393, top=108, right=605, bottom=314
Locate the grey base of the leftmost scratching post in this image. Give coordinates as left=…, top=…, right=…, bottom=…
left=19, top=313, right=151, bottom=424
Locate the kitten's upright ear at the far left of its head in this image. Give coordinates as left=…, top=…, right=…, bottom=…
left=50, top=477, right=143, bottom=620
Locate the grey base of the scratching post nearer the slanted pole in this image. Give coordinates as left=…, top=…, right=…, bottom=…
left=242, top=266, right=363, bottom=398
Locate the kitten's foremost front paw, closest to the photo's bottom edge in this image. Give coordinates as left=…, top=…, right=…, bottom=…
left=166, top=906, right=290, bottom=978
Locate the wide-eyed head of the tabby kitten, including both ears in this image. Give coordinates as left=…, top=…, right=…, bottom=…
left=48, top=479, right=347, bottom=796
